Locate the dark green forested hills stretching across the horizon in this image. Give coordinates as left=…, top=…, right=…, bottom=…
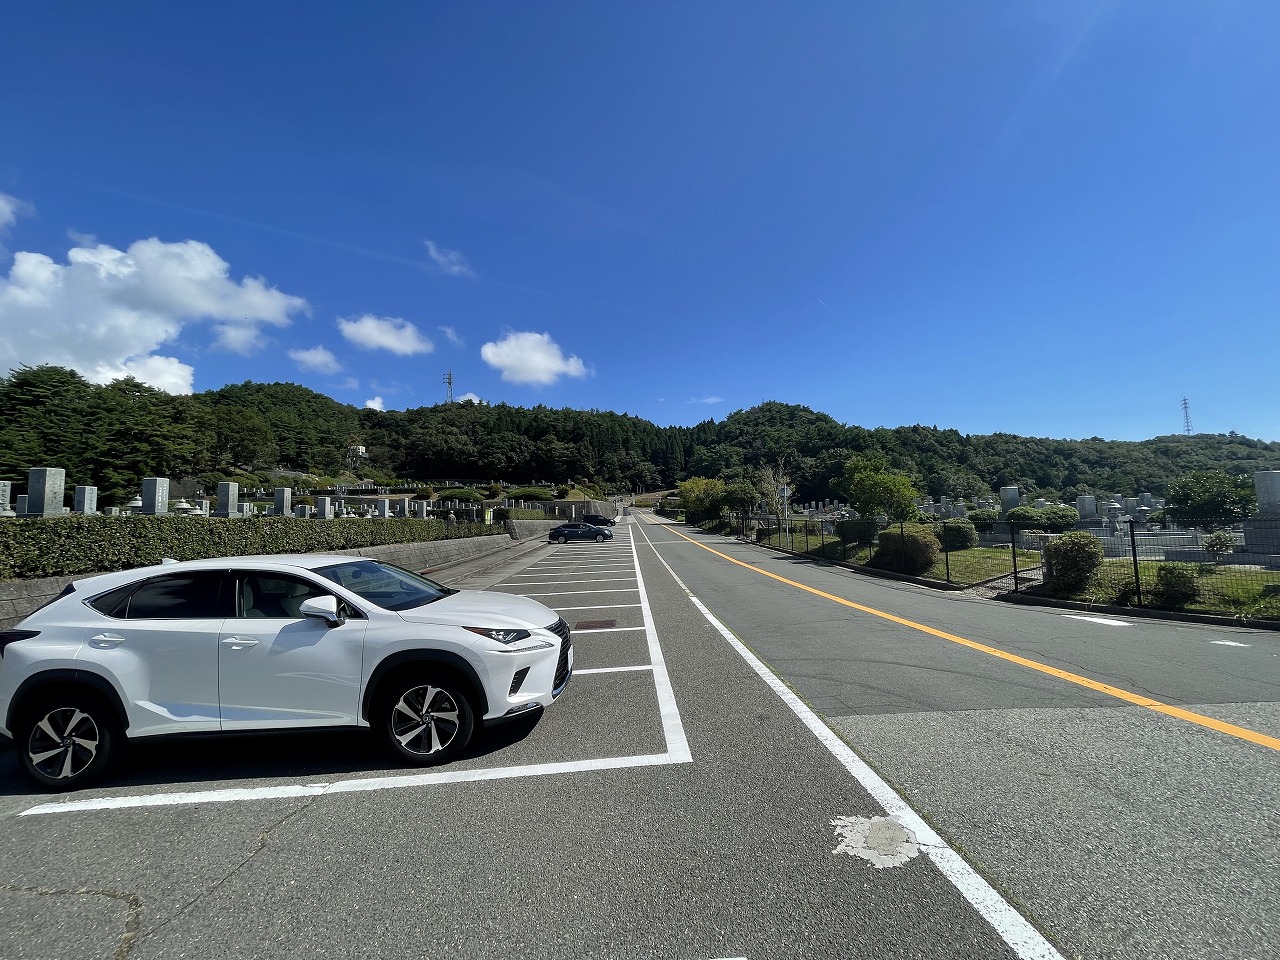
left=0, top=366, right=1280, bottom=504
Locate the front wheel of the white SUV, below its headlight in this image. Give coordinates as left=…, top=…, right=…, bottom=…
left=372, top=669, right=475, bottom=767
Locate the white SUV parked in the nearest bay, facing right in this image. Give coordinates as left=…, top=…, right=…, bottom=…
left=0, top=554, right=573, bottom=790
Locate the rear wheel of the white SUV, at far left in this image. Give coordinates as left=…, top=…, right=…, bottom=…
left=14, top=686, right=124, bottom=791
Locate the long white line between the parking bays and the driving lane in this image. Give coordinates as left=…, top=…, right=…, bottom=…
left=636, top=522, right=1065, bottom=960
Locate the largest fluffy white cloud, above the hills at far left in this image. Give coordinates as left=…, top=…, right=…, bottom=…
left=0, top=237, right=308, bottom=393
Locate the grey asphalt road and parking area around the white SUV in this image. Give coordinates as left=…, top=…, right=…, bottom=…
left=0, top=518, right=1280, bottom=959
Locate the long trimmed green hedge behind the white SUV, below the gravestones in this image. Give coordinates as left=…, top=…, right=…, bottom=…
left=0, top=516, right=503, bottom=580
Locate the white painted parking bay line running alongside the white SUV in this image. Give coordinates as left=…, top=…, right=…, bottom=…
left=18, top=754, right=689, bottom=817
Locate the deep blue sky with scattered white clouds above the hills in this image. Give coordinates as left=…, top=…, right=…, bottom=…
left=0, top=0, right=1280, bottom=440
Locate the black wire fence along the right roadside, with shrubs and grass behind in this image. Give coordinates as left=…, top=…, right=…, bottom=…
left=728, top=513, right=1280, bottom=620
